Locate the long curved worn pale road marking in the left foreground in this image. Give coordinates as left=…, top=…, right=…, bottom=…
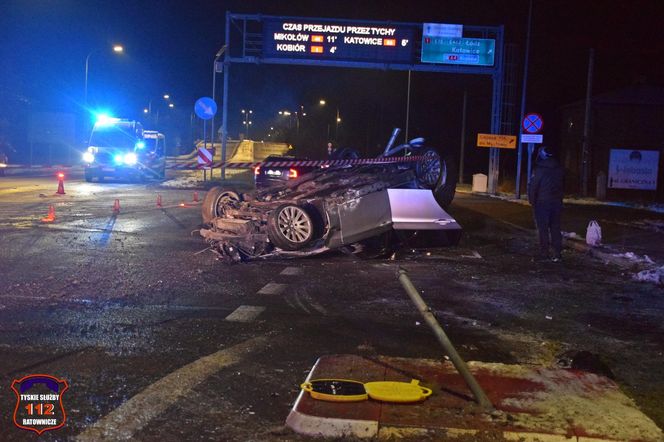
left=76, top=336, right=268, bottom=441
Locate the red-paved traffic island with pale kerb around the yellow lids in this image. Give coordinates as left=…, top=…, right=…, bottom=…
left=286, top=355, right=664, bottom=441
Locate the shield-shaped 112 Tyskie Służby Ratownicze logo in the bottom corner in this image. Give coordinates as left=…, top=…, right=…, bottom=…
left=11, top=374, right=69, bottom=435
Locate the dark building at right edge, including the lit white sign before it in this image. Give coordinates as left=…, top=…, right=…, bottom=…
left=559, top=85, right=664, bottom=202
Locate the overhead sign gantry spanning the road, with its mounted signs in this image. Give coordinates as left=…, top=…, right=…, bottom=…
left=221, top=12, right=503, bottom=193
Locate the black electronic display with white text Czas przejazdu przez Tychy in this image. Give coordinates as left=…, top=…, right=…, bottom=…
left=263, top=18, right=415, bottom=63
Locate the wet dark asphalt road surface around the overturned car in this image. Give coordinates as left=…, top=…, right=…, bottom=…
left=0, top=174, right=664, bottom=441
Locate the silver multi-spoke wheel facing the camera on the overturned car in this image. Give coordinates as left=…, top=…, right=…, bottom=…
left=267, top=204, right=315, bottom=250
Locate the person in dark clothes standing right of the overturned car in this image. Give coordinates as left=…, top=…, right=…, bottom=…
left=528, top=146, right=564, bottom=262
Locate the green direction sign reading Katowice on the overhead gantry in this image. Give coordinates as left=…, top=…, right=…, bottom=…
left=421, top=34, right=496, bottom=66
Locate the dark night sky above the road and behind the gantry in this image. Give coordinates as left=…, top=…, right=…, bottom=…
left=0, top=0, right=664, bottom=162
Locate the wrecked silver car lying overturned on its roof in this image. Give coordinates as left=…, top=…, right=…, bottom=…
left=200, top=130, right=461, bottom=262
